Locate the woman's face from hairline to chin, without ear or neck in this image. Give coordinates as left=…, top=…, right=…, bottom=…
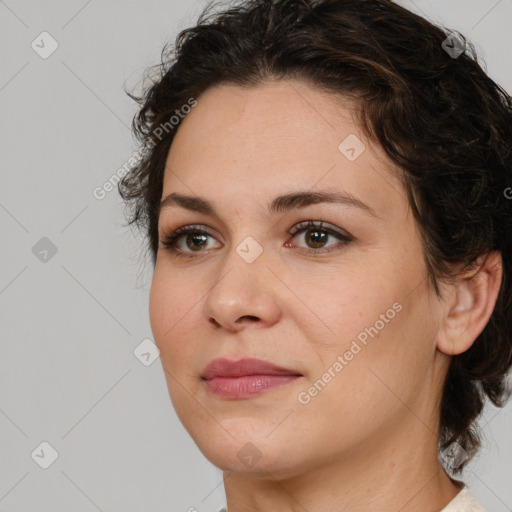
left=150, top=81, right=446, bottom=476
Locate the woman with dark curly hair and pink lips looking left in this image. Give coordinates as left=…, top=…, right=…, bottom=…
left=120, top=0, right=512, bottom=512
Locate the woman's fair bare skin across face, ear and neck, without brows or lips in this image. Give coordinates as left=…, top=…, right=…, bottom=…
left=150, top=80, right=501, bottom=512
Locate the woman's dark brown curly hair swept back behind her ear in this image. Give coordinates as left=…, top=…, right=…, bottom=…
left=118, top=0, right=512, bottom=473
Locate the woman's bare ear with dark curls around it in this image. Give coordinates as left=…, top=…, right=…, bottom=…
left=437, top=251, right=503, bottom=355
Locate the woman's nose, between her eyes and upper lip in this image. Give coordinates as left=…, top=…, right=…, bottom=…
left=203, top=249, right=281, bottom=332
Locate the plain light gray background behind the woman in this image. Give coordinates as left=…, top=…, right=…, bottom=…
left=0, top=0, right=512, bottom=512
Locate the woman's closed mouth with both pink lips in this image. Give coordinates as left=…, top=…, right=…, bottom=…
left=201, top=358, right=303, bottom=399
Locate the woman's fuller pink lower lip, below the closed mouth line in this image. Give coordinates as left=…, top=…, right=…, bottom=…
left=204, top=375, right=300, bottom=398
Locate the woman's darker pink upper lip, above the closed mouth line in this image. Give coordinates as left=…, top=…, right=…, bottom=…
left=201, top=357, right=301, bottom=380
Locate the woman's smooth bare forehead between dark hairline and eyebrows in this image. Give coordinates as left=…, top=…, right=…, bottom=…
left=163, top=80, right=403, bottom=218
